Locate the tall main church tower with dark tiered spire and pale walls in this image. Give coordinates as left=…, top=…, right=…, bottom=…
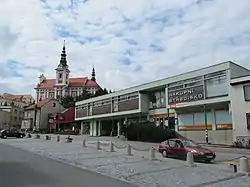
left=55, top=40, right=70, bottom=97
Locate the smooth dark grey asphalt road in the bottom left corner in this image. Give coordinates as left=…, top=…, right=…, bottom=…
left=0, top=143, right=139, bottom=187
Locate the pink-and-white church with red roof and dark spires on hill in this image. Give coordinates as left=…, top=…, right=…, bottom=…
left=35, top=43, right=100, bottom=101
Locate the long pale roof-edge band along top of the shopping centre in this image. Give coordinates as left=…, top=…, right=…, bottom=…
left=76, top=61, right=238, bottom=106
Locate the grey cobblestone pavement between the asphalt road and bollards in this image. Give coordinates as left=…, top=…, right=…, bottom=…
left=0, top=137, right=250, bottom=187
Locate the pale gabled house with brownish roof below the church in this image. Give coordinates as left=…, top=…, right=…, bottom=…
left=21, top=98, right=65, bottom=131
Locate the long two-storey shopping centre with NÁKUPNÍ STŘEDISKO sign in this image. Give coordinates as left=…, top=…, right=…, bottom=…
left=76, top=62, right=250, bottom=144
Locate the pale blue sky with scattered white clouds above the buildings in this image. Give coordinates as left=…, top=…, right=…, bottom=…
left=0, top=0, right=250, bottom=94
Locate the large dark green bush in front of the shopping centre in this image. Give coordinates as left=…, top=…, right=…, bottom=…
left=125, top=122, right=176, bottom=143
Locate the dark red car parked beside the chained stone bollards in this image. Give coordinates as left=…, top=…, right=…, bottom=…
left=159, top=138, right=216, bottom=162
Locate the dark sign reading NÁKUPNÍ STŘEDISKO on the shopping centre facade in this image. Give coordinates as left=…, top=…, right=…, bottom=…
left=168, top=86, right=204, bottom=105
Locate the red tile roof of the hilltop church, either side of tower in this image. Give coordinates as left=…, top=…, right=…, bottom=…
left=36, top=77, right=100, bottom=89
